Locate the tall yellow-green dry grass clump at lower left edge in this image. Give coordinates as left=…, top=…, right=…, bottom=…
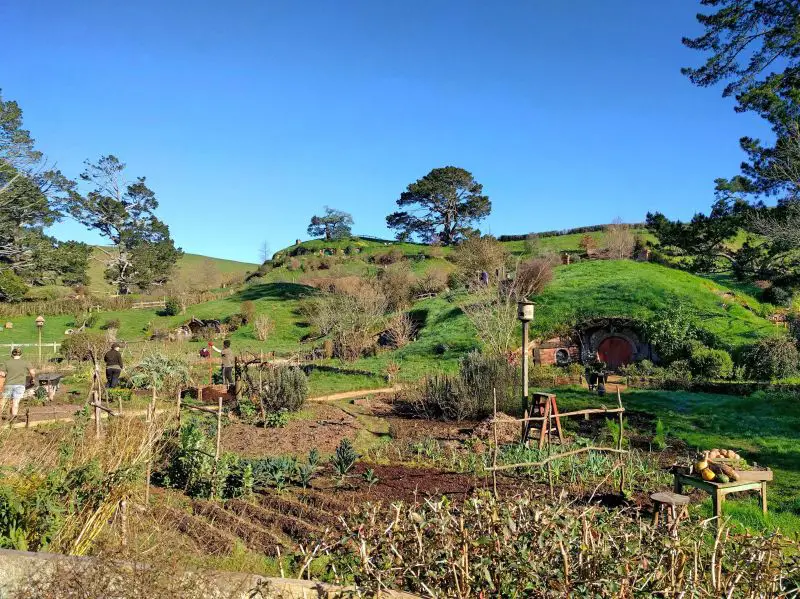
left=0, top=410, right=165, bottom=555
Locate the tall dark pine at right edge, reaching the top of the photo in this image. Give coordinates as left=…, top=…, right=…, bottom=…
left=676, top=0, right=800, bottom=285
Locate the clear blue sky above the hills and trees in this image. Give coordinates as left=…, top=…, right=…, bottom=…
left=0, top=0, right=766, bottom=261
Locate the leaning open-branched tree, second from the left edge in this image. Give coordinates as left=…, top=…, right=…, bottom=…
left=70, top=155, right=183, bottom=294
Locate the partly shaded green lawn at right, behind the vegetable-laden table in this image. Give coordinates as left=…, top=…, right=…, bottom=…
left=553, top=388, right=800, bottom=534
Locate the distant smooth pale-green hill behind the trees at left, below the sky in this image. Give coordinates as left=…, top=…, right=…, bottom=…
left=89, top=247, right=258, bottom=295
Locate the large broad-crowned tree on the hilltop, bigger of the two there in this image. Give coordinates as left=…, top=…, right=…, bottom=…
left=386, top=166, right=492, bottom=245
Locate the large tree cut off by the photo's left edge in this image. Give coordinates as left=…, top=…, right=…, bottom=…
left=0, top=91, right=90, bottom=292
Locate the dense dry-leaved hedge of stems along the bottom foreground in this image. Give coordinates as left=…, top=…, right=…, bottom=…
left=327, top=494, right=800, bottom=598
